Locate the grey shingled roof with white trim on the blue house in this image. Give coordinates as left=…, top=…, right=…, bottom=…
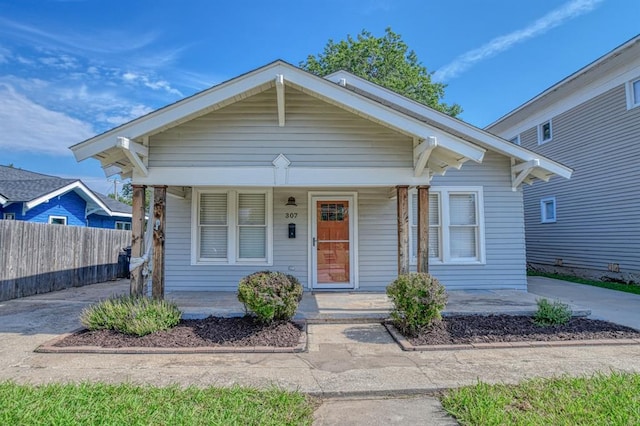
left=0, top=166, right=131, bottom=217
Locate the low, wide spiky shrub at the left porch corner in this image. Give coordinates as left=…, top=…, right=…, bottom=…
left=80, top=296, right=181, bottom=336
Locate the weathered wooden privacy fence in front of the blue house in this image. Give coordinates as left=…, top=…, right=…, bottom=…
left=0, top=220, right=131, bottom=301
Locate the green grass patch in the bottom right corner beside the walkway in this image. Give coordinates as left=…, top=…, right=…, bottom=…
left=442, top=372, right=640, bottom=426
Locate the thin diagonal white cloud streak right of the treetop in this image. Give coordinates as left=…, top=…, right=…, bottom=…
left=433, top=0, right=603, bottom=81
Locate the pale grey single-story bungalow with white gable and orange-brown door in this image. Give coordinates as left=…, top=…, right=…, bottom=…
left=71, top=61, right=571, bottom=294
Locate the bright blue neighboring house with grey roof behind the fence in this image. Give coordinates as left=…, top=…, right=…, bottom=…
left=0, top=166, right=131, bottom=230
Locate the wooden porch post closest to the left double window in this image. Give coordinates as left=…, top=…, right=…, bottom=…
left=151, top=185, right=167, bottom=299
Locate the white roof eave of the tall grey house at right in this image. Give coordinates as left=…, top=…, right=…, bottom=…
left=485, top=34, right=640, bottom=133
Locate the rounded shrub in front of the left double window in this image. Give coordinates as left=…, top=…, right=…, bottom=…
left=238, top=271, right=302, bottom=322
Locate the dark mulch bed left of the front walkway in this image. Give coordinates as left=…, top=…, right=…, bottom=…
left=54, top=316, right=302, bottom=348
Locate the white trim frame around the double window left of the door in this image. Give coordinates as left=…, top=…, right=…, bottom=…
left=191, top=188, right=273, bottom=266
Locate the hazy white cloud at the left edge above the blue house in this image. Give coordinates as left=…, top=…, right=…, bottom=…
left=0, top=84, right=95, bottom=156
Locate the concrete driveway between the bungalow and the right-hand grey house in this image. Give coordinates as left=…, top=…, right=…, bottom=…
left=528, top=277, right=640, bottom=330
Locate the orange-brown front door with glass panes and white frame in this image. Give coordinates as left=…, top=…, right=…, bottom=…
left=311, top=197, right=354, bottom=289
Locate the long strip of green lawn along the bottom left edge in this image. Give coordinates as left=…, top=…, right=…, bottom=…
left=0, top=382, right=313, bottom=425
